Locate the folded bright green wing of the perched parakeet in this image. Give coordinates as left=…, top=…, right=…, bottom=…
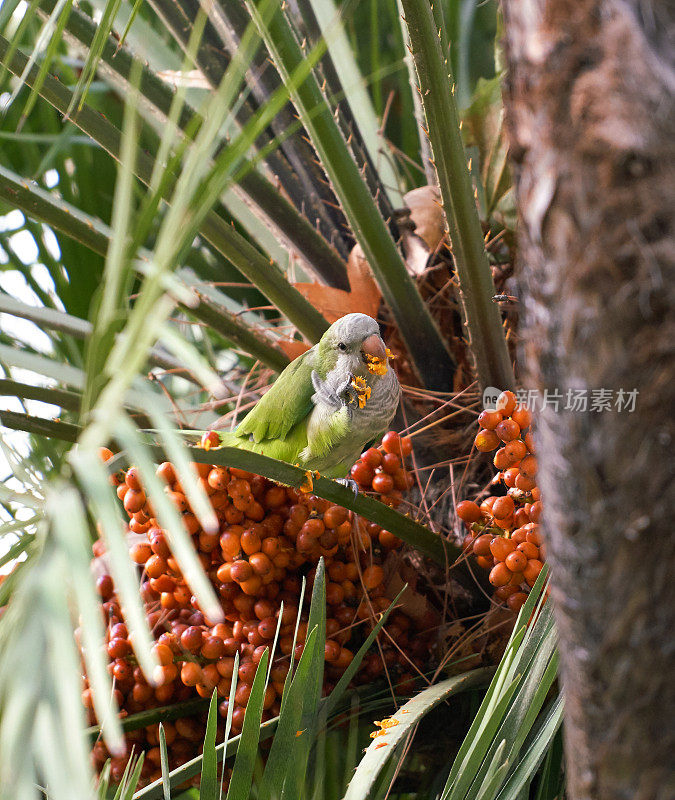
left=235, top=345, right=316, bottom=442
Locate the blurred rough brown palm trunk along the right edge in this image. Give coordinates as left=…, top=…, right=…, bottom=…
left=504, top=0, right=675, bottom=800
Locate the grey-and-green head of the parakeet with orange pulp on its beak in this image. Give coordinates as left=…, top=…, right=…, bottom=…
left=319, top=314, right=387, bottom=377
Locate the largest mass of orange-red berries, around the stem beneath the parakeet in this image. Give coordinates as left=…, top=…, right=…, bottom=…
left=88, top=432, right=431, bottom=782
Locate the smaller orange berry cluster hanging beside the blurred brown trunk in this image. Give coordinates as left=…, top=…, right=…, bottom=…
left=456, top=392, right=544, bottom=611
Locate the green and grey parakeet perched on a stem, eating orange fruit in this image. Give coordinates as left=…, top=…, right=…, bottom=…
left=220, top=314, right=400, bottom=478
